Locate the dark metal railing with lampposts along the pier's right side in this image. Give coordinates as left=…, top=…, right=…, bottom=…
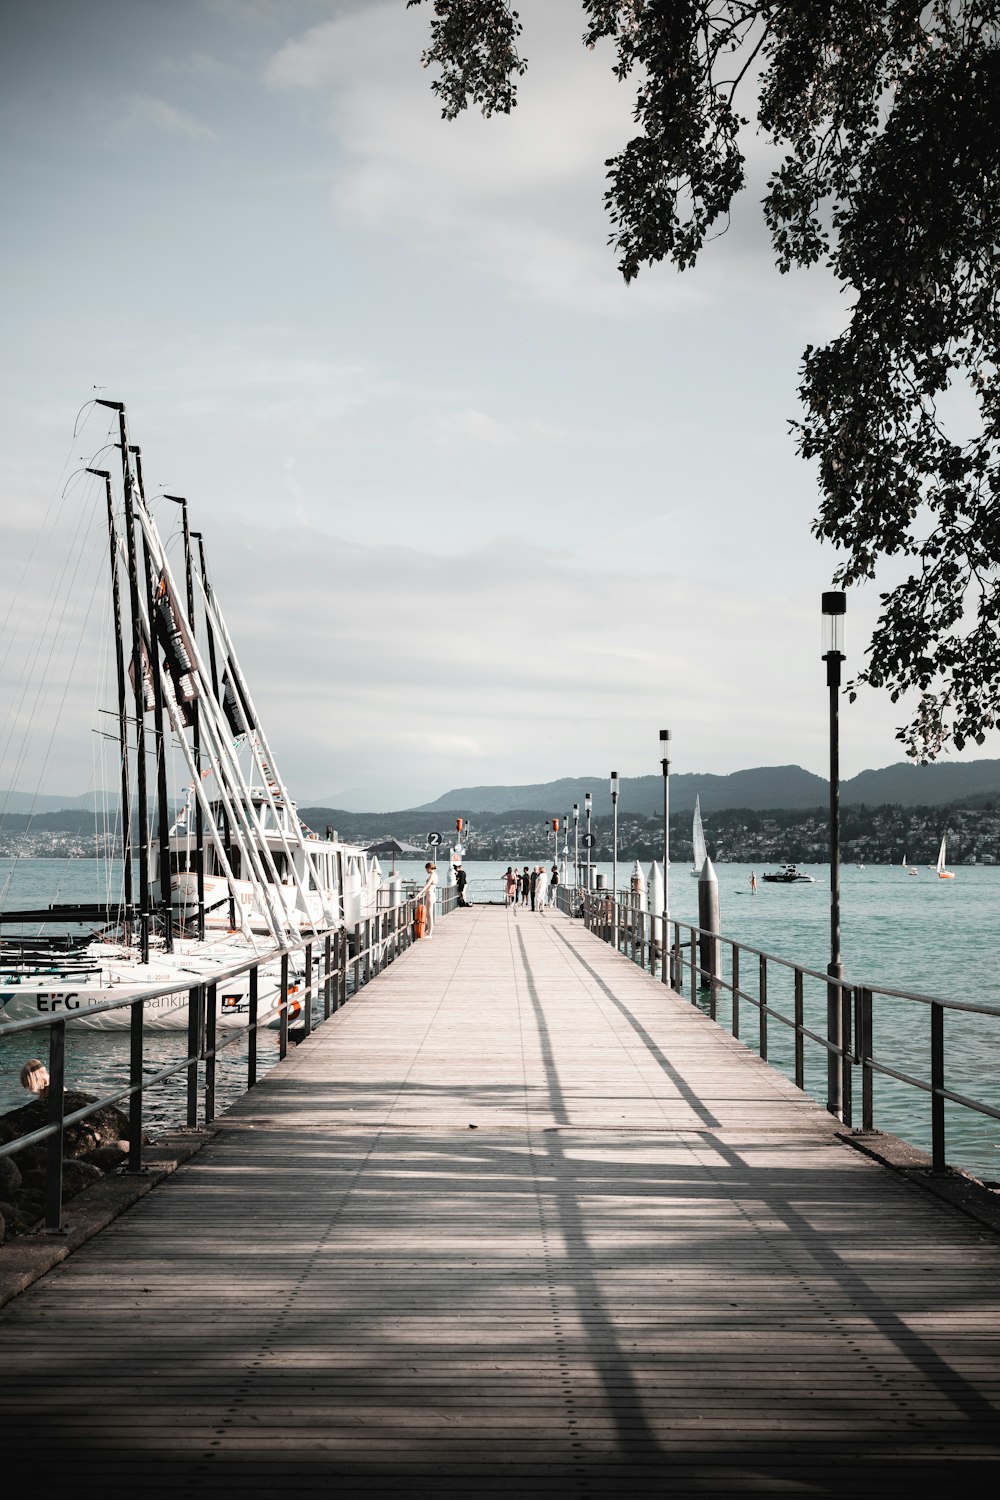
left=578, top=891, right=1000, bottom=1172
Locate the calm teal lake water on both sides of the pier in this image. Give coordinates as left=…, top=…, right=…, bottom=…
left=0, top=851, right=1000, bottom=1181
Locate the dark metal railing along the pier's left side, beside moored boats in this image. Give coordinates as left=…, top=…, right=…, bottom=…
left=0, top=890, right=454, bottom=1235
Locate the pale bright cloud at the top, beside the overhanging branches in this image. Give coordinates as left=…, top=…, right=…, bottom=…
left=265, top=0, right=844, bottom=332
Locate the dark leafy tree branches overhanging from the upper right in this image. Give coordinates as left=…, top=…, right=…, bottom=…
left=409, top=0, right=1000, bottom=761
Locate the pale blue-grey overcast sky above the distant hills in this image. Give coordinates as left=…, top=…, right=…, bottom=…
left=0, top=0, right=1000, bottom=810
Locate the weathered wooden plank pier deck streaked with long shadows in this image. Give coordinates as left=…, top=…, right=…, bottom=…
left=0, top=908, right=1000, bottom=1500
